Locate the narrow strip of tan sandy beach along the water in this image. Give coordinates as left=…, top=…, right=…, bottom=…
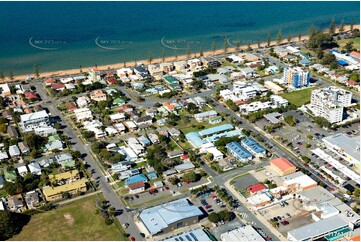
left=3, top=25, right=360, bottom=83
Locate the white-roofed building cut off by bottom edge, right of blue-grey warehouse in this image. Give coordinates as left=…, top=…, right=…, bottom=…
left=221, top=225, right=265, bottom=241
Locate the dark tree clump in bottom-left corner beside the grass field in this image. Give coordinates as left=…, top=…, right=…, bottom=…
left=0, top=210, right=30, bottom=241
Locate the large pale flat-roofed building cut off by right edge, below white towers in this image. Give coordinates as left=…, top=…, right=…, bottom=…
left=322, top=134, right=360, bottom=164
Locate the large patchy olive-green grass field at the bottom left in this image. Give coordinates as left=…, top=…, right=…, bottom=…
left=12, top=195, right=126, bottom=241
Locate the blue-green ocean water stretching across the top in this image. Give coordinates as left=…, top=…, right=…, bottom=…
left=0, top=1, right=360, bottom=75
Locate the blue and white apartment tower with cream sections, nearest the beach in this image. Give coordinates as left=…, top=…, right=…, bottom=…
left=283, top=67, right=310, bottom=88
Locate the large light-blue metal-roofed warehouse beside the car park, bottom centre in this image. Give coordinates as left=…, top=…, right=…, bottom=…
left=139, top=198, right=203, bottom=235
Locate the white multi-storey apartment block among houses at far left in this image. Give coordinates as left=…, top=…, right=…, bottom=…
left=20, top=110, right=50, bottom=132
